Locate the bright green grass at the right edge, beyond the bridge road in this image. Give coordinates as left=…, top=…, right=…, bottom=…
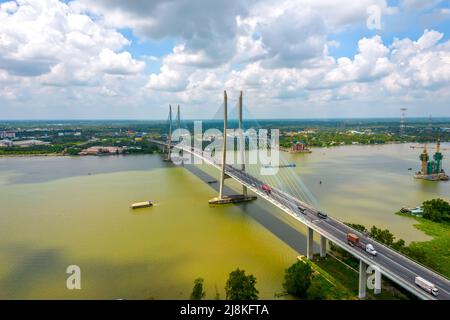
left=398, top=213, right=450, bottom=278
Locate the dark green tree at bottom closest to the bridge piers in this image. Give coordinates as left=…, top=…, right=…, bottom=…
left=283, top=261, right=312, bottom=299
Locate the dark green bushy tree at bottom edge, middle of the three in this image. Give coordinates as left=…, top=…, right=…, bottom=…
left=225, top=268, right=259, bottom=300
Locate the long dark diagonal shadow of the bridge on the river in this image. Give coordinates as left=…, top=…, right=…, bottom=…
left=184, top=165, right=318, bottom=253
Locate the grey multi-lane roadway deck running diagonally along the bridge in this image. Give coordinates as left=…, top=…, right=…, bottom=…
left=152, top=142, right=450, bottom=300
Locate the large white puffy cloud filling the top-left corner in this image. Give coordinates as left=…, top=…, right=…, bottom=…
left=0, top=0, right=145, bottom=84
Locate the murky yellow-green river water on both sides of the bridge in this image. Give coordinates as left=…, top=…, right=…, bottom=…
left=0, top=144, right=450, bottom=299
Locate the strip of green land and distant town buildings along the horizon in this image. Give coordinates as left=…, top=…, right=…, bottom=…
left=0, top=118, right=450, bottom=156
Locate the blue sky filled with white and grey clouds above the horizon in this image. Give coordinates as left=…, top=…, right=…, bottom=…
left=0, top=0, right=450, bottom=119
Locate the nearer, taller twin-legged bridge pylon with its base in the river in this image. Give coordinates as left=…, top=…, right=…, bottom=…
left=208, top=91, right=256, bottom=204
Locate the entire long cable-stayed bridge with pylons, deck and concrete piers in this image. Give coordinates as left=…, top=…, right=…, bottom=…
left=150, top=93, right=450, bottom=300
